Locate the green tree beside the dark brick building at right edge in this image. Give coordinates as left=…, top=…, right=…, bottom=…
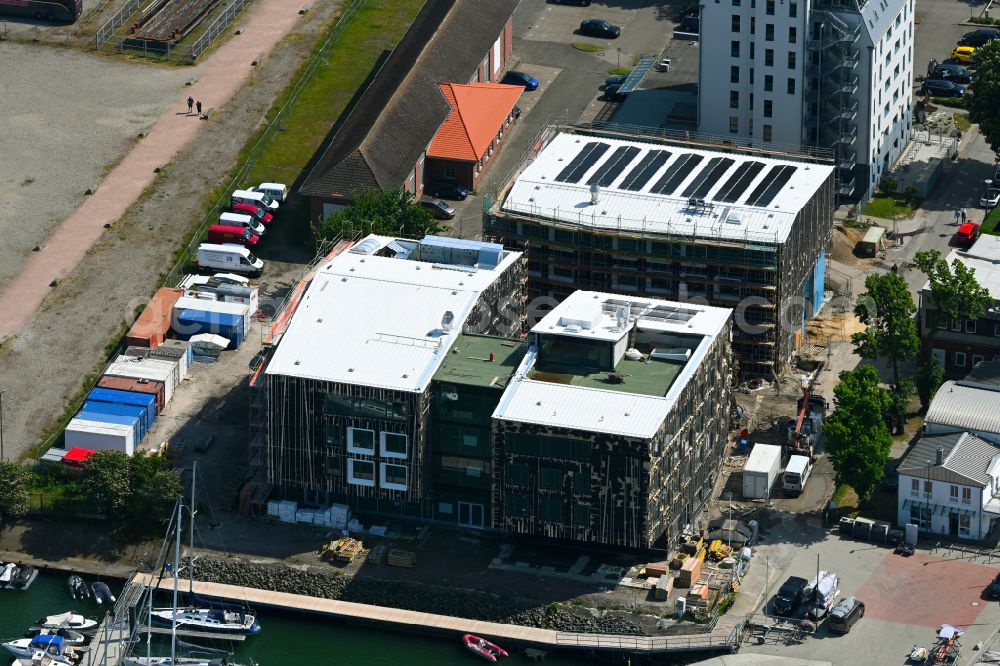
left=913, top=250, right=993, bottom=330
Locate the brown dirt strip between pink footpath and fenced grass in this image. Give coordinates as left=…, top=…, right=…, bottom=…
left=0, top=3, right=337, bottom=458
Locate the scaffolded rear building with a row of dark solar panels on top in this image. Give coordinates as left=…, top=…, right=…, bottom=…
left=485, top=126, right=835, bottom=376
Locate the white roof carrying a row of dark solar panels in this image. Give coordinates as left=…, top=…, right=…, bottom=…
left=501, top=133, right=833, bottom=243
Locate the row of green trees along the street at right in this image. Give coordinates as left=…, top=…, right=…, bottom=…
left=823, top=250, right=993, bottom=500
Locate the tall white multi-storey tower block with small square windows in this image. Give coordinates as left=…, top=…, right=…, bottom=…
left=698, top=0, right=914, bottom=199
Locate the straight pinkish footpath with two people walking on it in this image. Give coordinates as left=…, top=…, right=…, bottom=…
left=0, top=0, right=308, bottom=340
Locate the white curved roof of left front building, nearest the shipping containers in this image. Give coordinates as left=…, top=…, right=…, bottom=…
left=266, top=236, right=521, bottom=393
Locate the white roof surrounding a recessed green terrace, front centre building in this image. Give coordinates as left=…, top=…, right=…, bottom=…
left=493, top=291, right=732, bottom=439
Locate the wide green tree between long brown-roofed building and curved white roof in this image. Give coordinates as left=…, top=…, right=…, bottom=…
left=313, top=188, right=441, bottom=240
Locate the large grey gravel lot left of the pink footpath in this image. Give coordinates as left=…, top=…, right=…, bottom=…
left=0, top=42, right=188, bottom=284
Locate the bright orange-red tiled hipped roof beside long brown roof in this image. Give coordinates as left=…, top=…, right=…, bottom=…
left=427, top=83, right=524, bottom=162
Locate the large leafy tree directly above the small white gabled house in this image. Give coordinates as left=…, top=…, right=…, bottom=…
left=823, top=365, right=892, bottom=501
